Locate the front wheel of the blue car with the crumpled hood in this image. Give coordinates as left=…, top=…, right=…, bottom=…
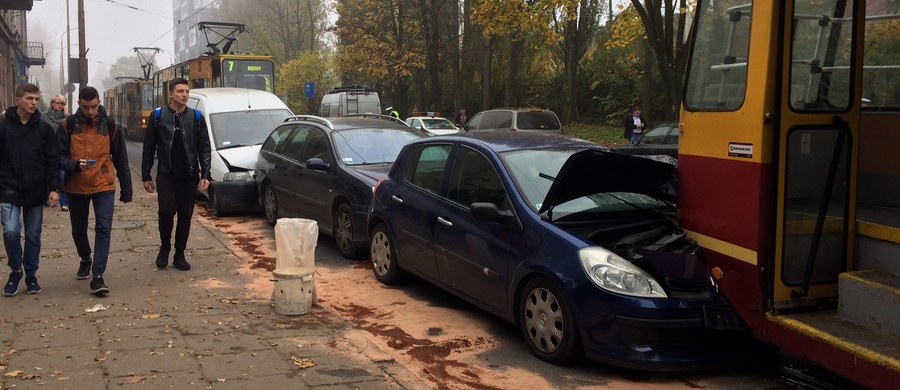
left=519, top=278, right=583, bottom=364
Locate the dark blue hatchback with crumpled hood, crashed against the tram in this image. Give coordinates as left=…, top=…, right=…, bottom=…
left=368, top=132, right=752, bottom=370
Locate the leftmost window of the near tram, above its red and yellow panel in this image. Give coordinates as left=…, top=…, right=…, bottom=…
left=684, top=0, right=753, bottom=111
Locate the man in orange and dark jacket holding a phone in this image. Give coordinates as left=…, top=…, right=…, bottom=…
left=57, top=87, right=132, bottom=295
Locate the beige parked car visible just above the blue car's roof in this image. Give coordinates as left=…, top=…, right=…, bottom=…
left=466, top=108, right=562, bottom=134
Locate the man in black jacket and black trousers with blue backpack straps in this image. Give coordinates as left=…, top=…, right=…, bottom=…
left=141, top=78, right=211, bottom=271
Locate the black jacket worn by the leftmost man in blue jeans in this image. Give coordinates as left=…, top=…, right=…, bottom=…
left=0, top=106, right=59, bottom=207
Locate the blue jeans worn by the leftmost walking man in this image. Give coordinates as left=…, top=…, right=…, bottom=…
left=0, top=203, right=44, bottom=276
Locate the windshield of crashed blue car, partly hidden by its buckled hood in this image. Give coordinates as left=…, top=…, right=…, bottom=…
left=500, top=149, right=671, bottom=220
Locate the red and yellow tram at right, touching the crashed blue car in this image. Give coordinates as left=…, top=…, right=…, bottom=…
left=678, top=0, right=900, bottom=388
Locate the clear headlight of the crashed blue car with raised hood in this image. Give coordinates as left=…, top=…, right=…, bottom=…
left=578, top=247, right=668, bottom=298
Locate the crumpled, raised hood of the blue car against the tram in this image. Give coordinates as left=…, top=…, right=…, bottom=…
left=538, top=149, right=677, bottom=213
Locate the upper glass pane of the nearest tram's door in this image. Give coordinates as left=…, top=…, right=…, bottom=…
left=790, top=0, right=853, bottom=111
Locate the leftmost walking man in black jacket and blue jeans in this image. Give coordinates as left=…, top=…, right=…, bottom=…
left=0, top=84, right=59, bottom=297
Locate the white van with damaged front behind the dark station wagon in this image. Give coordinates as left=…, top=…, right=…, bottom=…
left=187, top=88, right=293, bottom=216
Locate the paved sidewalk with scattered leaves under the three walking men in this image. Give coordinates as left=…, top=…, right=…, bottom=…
left=0, top=169, right=429, bottom=390
